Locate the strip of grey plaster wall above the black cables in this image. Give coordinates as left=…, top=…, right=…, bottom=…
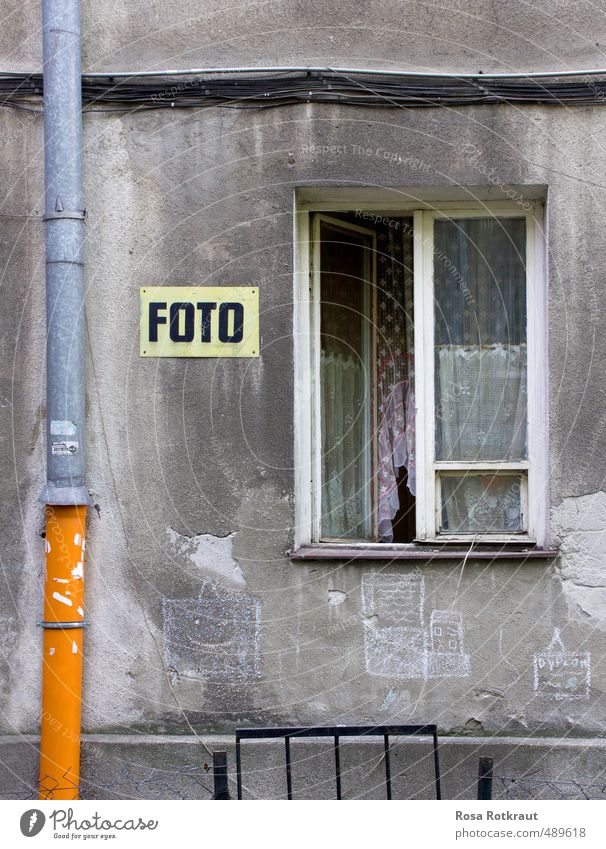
left=0, top=0, right=606, bottom=72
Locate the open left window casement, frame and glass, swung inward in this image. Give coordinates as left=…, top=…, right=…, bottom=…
left=312, top=215, right=376, bottom=540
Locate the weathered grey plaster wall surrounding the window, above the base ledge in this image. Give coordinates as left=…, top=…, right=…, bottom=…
left=0, top=2, right=606, bottom=800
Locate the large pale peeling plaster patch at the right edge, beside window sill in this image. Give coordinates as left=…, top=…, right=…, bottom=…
left=551, top=491, right=606, bottom=632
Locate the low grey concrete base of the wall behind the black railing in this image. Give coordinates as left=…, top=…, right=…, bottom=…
left=0, top=734, right=606, bottom=800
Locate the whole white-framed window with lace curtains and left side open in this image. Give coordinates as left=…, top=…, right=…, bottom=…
left=295, top=195, right=546, bottom=547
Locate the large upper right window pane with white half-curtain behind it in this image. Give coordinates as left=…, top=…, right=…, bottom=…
left=434, top=218, right=527, bottom=460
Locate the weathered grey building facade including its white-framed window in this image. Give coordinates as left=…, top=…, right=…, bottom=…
left=0, top=0, right=606, bottom=798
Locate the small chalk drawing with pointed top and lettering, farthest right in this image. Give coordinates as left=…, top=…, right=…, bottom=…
left=533, top=628, right=591, bottom=702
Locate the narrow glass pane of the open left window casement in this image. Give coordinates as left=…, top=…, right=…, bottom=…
left=320, top=222, right=372, bottom=539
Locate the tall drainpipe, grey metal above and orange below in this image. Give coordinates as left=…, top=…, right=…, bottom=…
left=40, top=0, right=90, bottom=799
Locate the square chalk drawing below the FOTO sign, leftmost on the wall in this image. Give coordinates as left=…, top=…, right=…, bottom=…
left=162, top=579, right=261, bottom=682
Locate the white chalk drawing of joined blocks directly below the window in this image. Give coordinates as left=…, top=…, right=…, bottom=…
left=362, top=573, right=470, bottom=679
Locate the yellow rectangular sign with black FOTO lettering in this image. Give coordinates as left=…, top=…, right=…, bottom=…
left=140, top=286, right=259, bottom=357
